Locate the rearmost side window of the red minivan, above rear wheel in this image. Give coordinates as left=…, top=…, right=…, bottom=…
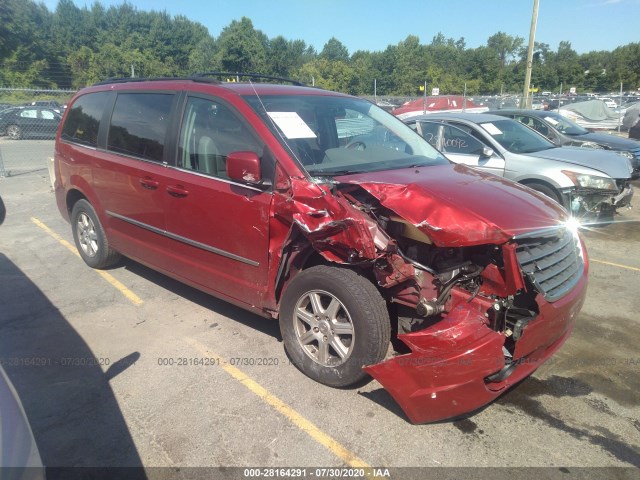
left=62, top=92, right=109, bottom=147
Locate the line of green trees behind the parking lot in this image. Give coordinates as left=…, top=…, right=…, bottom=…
left=0, top=0, right=640, bottom=96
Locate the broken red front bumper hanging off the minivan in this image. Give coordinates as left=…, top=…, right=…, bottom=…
left=364, top=271, right=587, bottom=423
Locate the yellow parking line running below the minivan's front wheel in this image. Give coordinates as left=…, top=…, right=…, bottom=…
left=185, top=337, right=371, bottom=468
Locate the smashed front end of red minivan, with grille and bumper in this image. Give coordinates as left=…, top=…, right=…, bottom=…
left=365, top=222, right=585, bottom=423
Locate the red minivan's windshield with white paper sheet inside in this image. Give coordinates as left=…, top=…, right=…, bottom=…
left=245, top=95, right=449, bottom=176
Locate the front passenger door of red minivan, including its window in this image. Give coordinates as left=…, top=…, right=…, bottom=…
left=164, top=96, right=272, bottom=305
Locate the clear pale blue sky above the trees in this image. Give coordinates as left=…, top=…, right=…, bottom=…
left=43, top=0, right=640, bottom=54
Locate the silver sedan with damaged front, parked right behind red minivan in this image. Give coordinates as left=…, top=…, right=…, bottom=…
left=407, top=113, right=633, bottom=223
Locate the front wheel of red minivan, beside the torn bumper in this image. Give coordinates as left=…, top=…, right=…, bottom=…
left=280, top=266, right=391, bottom=387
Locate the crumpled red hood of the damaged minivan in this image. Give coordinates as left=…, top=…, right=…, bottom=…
left=336, top=165, right=566, bottom=246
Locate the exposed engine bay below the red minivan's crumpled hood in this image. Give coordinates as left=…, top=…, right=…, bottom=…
left=337, top=185, right=538, bottom=363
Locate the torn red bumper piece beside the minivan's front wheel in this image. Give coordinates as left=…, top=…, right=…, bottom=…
left=364, top=304, right=504, bottom=423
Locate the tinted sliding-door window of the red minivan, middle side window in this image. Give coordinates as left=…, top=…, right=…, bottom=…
left=107, top=93, right=174, bottom=162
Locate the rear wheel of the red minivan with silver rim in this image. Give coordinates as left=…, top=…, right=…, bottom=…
left=71, top=199, right=120, bottom=269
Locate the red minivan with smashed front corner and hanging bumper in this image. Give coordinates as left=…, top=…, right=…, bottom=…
left=55, top=76, right=587, bottom=423
